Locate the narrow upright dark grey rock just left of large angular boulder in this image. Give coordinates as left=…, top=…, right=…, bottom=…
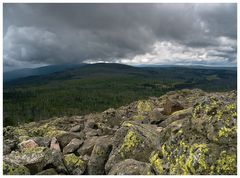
left=87, top=137, right=112, bottom=175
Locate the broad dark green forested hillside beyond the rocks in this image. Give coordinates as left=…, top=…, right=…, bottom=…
left=3, top=63, right=237, bottom=126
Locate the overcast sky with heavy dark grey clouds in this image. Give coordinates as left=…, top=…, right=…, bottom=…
left=3, top=3, right=237, bottom=70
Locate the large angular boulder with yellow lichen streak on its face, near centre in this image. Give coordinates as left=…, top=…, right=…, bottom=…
left=105, top=122, right=159, bottom=172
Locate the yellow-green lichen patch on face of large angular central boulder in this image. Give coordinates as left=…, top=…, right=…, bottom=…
left=119, top=130, right=141, bottom=156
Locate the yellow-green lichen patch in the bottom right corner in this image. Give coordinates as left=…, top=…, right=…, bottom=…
left=216, top=151, right=237, bottom=175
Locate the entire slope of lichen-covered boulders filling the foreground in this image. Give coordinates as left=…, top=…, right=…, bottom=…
left=3, top=89, right=237, bottom=175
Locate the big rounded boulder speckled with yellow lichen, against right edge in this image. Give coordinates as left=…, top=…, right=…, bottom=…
left=191, top=93, right=237, bottom=144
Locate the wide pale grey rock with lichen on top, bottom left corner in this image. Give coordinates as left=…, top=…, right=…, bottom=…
left=3, top=147, right=66, bottom=174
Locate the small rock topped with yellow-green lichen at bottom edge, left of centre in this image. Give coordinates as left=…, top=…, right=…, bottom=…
left=64, top=153, right=86, bottom=175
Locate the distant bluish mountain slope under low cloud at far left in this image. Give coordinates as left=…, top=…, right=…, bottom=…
left=3, top=64, right=85, bottom=82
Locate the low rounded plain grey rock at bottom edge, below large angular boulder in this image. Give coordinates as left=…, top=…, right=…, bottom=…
left=108, top=159, right=154, bottom=175
